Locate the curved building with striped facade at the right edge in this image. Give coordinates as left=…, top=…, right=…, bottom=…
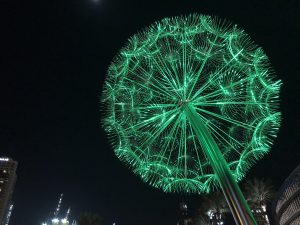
left=275, top=165, right=300, bottom=225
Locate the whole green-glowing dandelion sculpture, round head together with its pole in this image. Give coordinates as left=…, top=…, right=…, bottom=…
left=102, top=15, right=281, bottom=224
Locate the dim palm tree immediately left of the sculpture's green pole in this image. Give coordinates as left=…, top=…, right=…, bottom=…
left=195, top=192, right=229, bottom=225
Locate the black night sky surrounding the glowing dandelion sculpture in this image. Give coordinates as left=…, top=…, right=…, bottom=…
left=0, top=0, right=300, bottom=225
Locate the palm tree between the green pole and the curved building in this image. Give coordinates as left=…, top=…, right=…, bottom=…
left=245, top=178, right=275, bottom=225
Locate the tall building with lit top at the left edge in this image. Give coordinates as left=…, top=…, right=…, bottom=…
left=0, top=157, right=18, bottom=225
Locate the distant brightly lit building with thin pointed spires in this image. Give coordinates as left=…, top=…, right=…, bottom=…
left=42, top=194, right=76, bottom=225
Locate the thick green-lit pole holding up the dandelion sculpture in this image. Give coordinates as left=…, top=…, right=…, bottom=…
left=184, top=102, right=257, bottom=225
